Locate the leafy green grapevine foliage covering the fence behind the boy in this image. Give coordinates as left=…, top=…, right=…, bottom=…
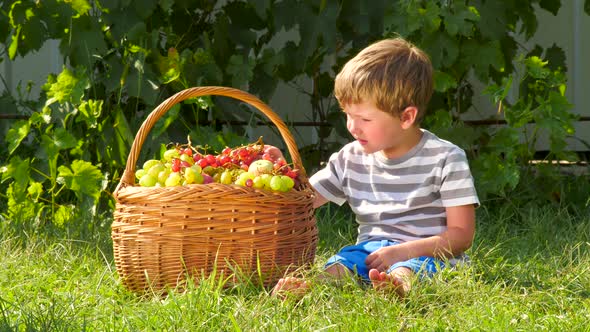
left=0, top=0, right=587, bottom=231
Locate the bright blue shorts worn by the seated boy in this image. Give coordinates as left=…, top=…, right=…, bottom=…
left=324, top=240, right=454, bottom=281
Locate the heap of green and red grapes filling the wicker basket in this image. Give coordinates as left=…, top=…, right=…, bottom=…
left=135, top=139, right=300, bottom=192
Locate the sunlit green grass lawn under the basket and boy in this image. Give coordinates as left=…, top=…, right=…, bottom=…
left=0, top=206, right=590, bottom=331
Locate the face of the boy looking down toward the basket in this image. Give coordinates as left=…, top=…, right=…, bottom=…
left=344, top=102, right=414, bottom=157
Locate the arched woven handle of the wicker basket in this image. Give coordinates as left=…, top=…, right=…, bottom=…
left=115, top=86, right=306, bottom=192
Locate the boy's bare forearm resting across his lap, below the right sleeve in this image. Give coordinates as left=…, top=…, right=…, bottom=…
left=365, top=205, right=475, bottom=271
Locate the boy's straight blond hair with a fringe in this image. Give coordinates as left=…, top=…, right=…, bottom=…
left=334, top=38, right=433, bottom=123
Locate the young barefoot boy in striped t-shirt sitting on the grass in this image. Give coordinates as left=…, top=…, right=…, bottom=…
left=273, top=38, right=479, bottom=297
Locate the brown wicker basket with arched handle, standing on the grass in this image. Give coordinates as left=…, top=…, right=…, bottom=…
left=112, top=87, right=317, bottom=292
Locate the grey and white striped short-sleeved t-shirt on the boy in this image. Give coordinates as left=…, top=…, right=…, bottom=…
left=309, top=130, right=479, bottom=243
